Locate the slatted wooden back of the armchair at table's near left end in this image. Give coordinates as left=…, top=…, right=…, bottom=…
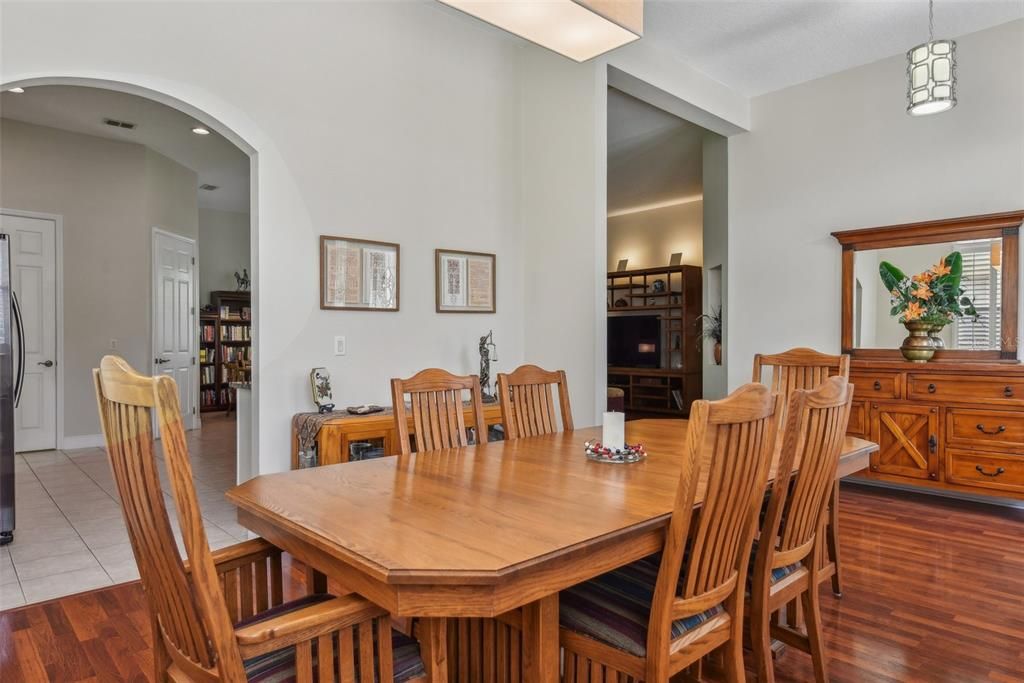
left=93, top=356, right=245, bottom=681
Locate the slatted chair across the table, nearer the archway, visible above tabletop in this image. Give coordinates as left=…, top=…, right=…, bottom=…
left=391, top=368, right=487, bottom=456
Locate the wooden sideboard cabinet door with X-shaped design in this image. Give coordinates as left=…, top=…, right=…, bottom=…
left=869, top=403, right=939, bottom=479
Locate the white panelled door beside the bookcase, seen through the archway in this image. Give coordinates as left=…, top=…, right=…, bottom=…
left=153, top=228, right=199, bottom=429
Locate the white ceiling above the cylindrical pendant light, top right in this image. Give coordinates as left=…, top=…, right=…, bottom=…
left=643, top=0, right=1024, bottom=96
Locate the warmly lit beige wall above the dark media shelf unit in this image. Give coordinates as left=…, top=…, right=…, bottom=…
left=607, top=201, right=703, bottom=270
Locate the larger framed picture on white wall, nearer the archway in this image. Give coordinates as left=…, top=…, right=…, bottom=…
left=321, top=234, right=399, bottom=310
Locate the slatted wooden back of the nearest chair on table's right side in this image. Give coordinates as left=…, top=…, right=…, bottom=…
left=647, top=384, right=781, bottom=652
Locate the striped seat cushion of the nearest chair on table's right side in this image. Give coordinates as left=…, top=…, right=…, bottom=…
left=559, top=555, right=723, bottom=657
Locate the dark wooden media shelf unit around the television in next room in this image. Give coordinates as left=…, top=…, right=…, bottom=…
left=607, top=265, right=703, bottom=418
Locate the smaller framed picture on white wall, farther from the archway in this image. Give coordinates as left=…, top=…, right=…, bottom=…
left=434, top=249, right=497, bottom=313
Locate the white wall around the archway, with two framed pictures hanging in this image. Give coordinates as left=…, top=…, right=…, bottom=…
left=0, top=2, right=528, bottom=471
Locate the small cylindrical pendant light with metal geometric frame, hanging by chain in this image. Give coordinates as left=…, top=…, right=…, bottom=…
left=906, top=0, right=956, bottom=116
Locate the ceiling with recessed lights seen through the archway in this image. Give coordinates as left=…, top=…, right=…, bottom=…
left=0, top=85, right=249, bottom=213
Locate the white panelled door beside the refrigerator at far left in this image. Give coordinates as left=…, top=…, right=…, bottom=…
left=0, top=214, right=57, bottom=453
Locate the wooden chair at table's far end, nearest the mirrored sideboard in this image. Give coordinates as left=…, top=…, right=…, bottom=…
left=754, top=348, right=850, bottom=598
